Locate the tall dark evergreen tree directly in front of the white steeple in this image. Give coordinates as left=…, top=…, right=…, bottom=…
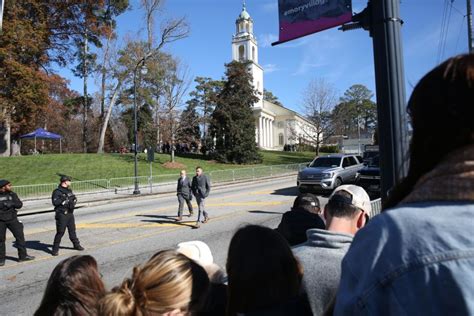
left=211, top=61, right=261, bottom=163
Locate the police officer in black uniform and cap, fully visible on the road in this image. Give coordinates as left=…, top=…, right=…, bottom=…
left=51, top=176, right=84, bottom=256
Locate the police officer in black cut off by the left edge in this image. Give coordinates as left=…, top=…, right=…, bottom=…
left=0, top=180, right=35, bottom=266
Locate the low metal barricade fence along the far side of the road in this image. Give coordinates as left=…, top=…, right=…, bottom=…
left=14, top=163, right=307, bottom=200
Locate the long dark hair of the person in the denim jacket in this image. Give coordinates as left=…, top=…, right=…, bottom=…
left=384, top=54, right=474, bottom=207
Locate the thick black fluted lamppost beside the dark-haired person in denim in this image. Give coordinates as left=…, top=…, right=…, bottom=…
left=369, top=0, right=408, bottom=206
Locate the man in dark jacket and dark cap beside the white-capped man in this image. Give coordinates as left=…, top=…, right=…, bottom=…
left=276, top=193, right=325, bottom=246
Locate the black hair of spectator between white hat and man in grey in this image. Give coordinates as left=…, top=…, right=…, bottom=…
left=226, top=225, right=302, bottom=316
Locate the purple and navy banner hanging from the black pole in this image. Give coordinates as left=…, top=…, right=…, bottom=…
left=275, top=0, right=352, bottom=44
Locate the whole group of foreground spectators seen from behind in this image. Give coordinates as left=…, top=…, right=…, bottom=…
left=8, top=54, right=474, bottom=316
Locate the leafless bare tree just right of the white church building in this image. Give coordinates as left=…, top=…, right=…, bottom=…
left=299, top=78, right=337, bottom=155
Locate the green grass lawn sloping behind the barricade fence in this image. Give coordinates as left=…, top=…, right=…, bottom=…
left=0, top=151, right=314, bottom=185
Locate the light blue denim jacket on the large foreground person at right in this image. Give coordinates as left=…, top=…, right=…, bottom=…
left=335, top=202, right=474, bottom=315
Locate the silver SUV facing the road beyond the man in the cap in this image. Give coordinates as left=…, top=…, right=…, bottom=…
left=296, top=154, right=364, bottom=192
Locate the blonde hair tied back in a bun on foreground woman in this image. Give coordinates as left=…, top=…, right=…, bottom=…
left=99, top=250, right=203, bottom=316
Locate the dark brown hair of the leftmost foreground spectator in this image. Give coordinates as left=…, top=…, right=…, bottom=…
left=34, top=256, right=105, bottom=316
